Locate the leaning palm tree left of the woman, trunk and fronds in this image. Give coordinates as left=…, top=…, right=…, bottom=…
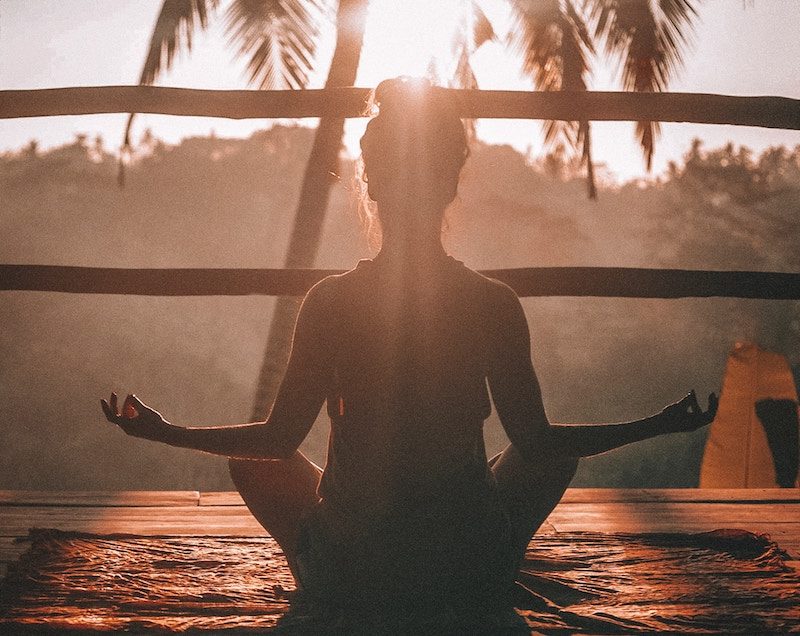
left=119, top=0, right=367, bottom=419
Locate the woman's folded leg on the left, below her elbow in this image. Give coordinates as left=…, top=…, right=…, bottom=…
left=228, top=451, right=322, bottom=581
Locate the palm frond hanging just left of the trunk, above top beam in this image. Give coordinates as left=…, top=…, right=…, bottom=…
left=225, top=0, right=323, bottom=89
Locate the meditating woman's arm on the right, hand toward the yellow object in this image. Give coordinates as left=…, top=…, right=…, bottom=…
left=487, top=286, right=717, bottom=461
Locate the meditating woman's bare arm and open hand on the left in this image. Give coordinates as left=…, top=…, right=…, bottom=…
left=100, top=280, right=332, bottom=459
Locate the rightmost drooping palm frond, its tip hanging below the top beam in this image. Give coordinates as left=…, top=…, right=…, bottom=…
left=584, top=0, right=697, bottom=170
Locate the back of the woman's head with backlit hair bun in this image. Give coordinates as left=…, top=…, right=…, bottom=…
left=361, top=77, right=468, bottom=237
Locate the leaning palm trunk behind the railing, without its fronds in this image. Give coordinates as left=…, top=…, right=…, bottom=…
left=252, top=0, right=368, bottom=420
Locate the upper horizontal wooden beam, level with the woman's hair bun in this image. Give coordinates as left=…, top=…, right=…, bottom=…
left=0, top=86, right=800, bottom=130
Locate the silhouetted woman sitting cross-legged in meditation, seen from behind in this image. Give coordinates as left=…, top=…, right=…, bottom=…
left=102, top=78, right=716, bottom=620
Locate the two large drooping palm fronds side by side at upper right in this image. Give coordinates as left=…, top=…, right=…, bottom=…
left=509, top=0, right=697, bottom=198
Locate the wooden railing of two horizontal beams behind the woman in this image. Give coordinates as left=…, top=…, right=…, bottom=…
left=0, top=86, right=800, bottom=300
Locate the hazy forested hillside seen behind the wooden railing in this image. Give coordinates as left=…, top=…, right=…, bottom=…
left=0, top=126, right=800, bottom=490
